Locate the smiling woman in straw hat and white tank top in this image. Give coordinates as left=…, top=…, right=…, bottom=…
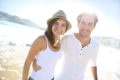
left=22, top=10, right=71, bottom=80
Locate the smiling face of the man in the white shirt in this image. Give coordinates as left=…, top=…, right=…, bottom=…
left=78, top=15, right=95, bottom=38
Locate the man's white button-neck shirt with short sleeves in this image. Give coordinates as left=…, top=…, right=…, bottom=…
left=55, top=34, right=99, bottom=80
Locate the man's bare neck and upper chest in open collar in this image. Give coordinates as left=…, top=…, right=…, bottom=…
left=75, top=33, right=91, bottom=47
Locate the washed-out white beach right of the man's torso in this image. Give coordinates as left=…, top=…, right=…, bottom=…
left=85, top=45, right=120, bottom=80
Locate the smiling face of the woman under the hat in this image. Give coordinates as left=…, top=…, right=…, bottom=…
left=52, top=19, right=67, bottom=36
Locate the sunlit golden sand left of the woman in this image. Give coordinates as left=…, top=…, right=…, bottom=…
left=0, top=43, right=29, bottom=80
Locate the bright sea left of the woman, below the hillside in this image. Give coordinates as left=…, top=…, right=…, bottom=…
left=0, top=20, right=44, bottom=44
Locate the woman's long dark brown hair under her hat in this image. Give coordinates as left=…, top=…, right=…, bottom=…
left=45, top=18, right=68, bottom=47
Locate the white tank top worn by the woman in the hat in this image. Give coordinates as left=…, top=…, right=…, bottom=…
left=31, top=36, right=62, bottom=80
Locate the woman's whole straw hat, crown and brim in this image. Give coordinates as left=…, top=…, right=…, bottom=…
left=47, top=10, right=71, bottom=30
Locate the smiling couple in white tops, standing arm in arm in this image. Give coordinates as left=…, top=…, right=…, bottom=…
left=22, top=10, right=99, bottom=80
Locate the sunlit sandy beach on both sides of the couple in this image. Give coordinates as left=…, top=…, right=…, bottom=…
left=0, top=43, right=120, bottom=80
